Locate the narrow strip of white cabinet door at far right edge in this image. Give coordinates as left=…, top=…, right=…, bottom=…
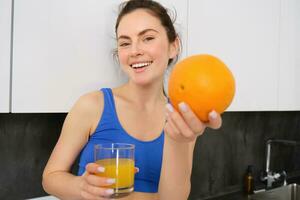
left=278, top=0, right=300, bottom=110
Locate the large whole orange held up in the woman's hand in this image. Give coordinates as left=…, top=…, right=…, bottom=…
left=168, top=55, right=235, bottom=122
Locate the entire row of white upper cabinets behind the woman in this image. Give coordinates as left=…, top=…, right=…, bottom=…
left=5, top=0, right=300, bottom=112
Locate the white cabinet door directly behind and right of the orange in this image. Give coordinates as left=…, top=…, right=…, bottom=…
left=188, top=0, right=280, bottom=111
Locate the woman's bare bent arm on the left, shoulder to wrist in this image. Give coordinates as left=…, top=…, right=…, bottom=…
left=43, top=92, right=108, bottom=199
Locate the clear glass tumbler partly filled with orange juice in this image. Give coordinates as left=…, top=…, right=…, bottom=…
left=94, top=143, right=135, bottom=198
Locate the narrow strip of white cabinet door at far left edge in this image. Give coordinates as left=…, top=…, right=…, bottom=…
left=0, top=0, right=12, bottom=112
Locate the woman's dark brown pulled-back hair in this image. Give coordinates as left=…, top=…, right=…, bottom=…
left=115, top=0, right=178, bottom=65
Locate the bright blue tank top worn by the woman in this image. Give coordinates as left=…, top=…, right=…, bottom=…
left=78, top=88, right=164, bottom=193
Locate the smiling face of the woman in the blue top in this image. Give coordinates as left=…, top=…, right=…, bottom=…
left=117, top=9, right=177, bottom=85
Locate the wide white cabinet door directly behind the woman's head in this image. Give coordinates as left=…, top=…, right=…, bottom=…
left=12, top=0, right=187, bottom=112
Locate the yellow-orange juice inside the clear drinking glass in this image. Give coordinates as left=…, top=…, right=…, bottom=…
left=96, top=158, right=134, bottom=189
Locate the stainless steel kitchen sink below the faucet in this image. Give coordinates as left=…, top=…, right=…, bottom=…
left=250, top=183, right=300, bottom=200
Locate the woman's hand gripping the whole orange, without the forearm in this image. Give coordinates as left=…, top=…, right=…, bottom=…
left=165, top=102, right=222, bottom=142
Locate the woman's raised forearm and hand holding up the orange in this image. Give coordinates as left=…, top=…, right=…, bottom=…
left=159, top=104, right=222, bottom=200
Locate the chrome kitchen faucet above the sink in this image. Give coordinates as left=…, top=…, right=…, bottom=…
left=261, top=139, right=300, bottom=188
